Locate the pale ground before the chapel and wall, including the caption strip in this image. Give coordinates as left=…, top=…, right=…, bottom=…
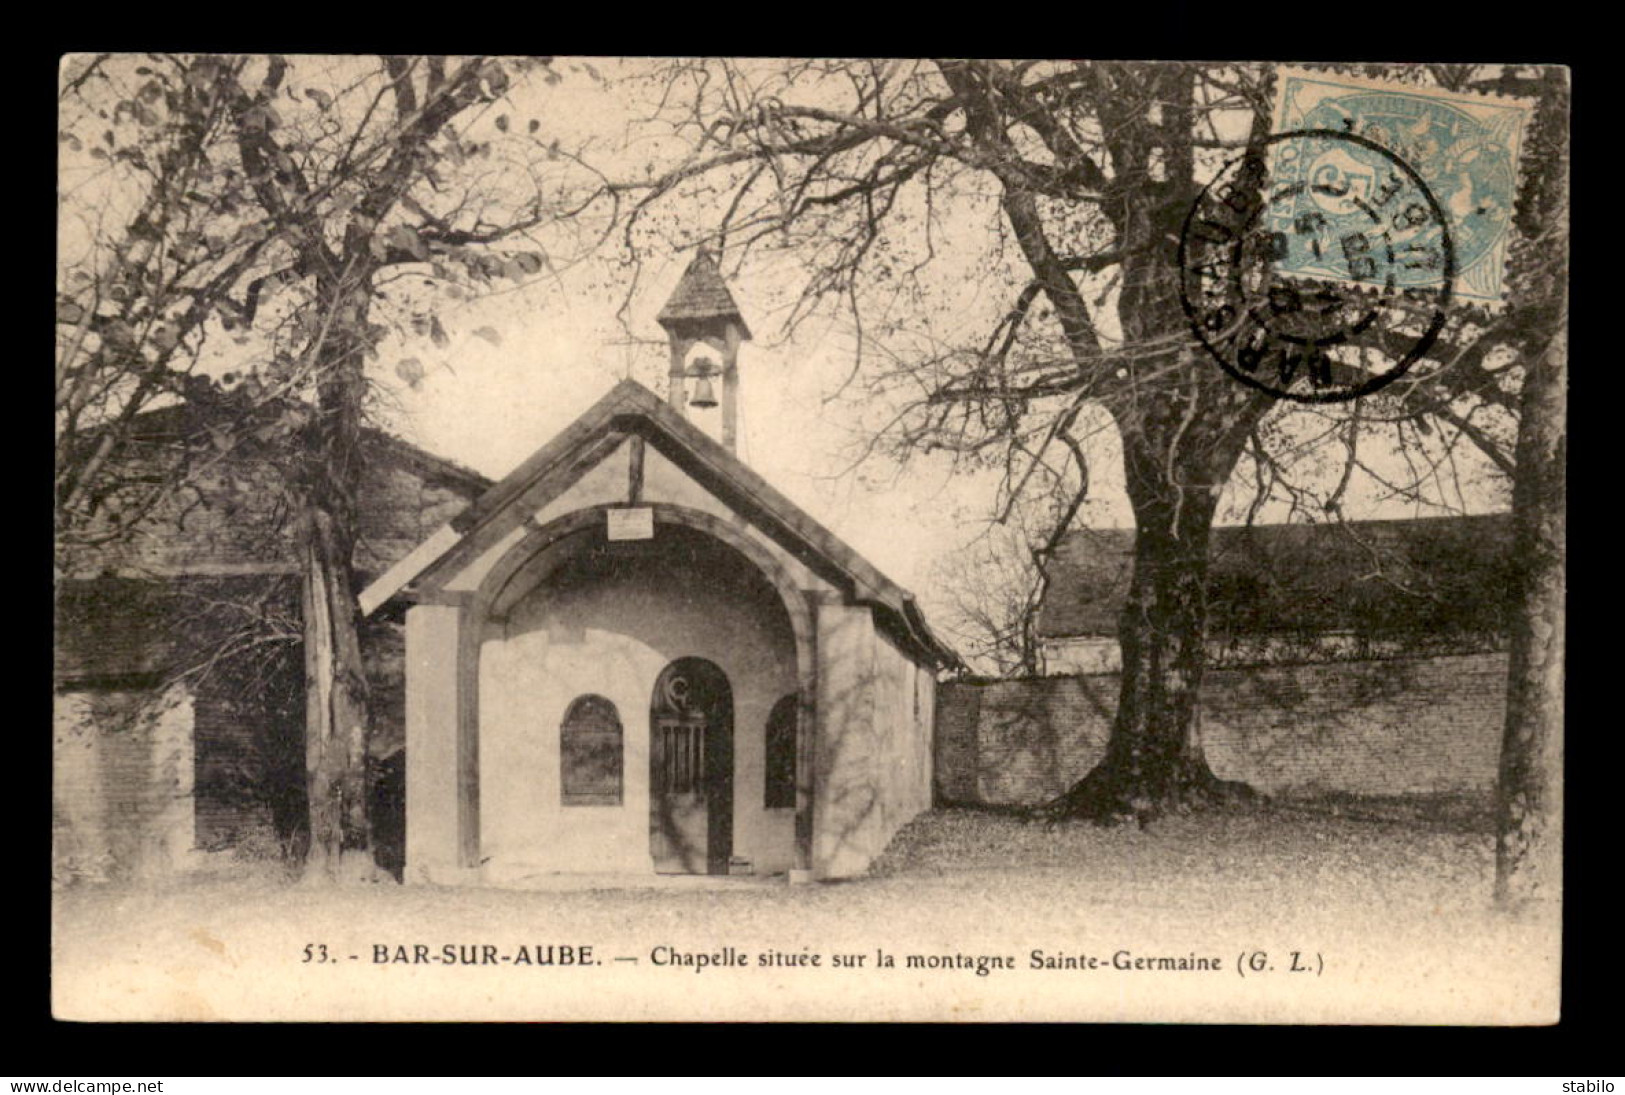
left=54, top=806, right=1560, bottom=1024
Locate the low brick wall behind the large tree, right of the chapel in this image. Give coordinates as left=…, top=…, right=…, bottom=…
left=934, top=653, right=1506, bottom=806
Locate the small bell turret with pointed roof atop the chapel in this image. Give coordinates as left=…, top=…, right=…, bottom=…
left=655, top=249, right=751, bottom=452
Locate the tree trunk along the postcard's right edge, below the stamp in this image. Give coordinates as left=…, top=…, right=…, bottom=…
left=1495, top=320, right=1568, bottom=908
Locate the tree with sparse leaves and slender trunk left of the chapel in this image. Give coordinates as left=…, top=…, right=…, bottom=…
left=57, top=55, right=601, bottom=879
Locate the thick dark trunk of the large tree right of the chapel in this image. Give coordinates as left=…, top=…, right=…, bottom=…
left=1042, top=65, right=1269, bottom=825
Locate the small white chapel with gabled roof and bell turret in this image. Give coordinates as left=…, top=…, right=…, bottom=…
left=361, top=252, right=959, bottom=884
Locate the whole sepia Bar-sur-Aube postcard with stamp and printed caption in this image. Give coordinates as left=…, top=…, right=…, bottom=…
left=50, top=54, right=1570, bottom=1025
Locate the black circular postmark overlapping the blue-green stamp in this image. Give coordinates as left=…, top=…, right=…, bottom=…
left=1180, top=130, right=1456, bottom=403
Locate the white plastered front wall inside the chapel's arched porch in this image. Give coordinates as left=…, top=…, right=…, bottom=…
left=474, top=545, right=796, bottom=881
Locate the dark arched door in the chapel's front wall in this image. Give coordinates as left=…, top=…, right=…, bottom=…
left=648, top=658, right=733, bottom=874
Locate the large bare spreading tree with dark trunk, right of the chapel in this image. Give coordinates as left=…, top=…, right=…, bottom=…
left=621, top=60, right=1560, bottom=819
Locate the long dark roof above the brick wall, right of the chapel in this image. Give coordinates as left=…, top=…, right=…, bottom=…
left=1038, top=513, right=1513, bottom=638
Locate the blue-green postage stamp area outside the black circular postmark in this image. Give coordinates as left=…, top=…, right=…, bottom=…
left=1272, top=68, right=1531, bottom=307
